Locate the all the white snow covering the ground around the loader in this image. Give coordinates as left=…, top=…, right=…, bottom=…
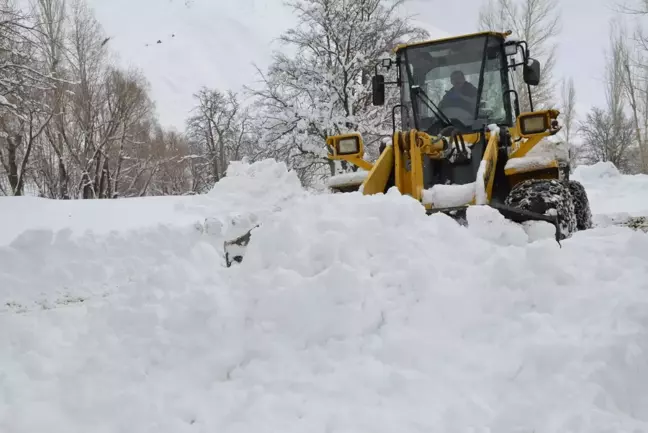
left=0, top=161, right=648, bottom=433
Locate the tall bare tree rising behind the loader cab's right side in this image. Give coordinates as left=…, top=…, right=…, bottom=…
left=478, top=0, right=560, bottom=111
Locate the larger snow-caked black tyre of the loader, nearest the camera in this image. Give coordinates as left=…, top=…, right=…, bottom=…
left=505, top=179, right=577, bottom=240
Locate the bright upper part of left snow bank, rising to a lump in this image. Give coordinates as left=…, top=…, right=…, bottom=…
left=0, top=159, right=306, bottom=246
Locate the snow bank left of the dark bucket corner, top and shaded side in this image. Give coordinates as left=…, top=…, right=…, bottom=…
left=0, top=160, right=305, bottom=311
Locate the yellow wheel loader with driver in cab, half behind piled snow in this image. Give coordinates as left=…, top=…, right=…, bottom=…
left=225, top=32, right=592, bottom=266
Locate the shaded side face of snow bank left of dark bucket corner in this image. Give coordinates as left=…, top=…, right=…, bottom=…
left=0, top=224, right=223, bottom=308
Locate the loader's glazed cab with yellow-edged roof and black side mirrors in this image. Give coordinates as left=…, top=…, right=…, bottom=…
left=373, top=32, right=540, bottom=135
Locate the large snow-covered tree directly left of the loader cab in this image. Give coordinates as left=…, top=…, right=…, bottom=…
left=251, top=0, right=427, bottom=184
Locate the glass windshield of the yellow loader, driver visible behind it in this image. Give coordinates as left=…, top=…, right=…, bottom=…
left=400, top=35, right=511, bottom=134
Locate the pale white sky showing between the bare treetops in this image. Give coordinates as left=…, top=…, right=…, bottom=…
left=90, top=0, right=640, bottom=129
